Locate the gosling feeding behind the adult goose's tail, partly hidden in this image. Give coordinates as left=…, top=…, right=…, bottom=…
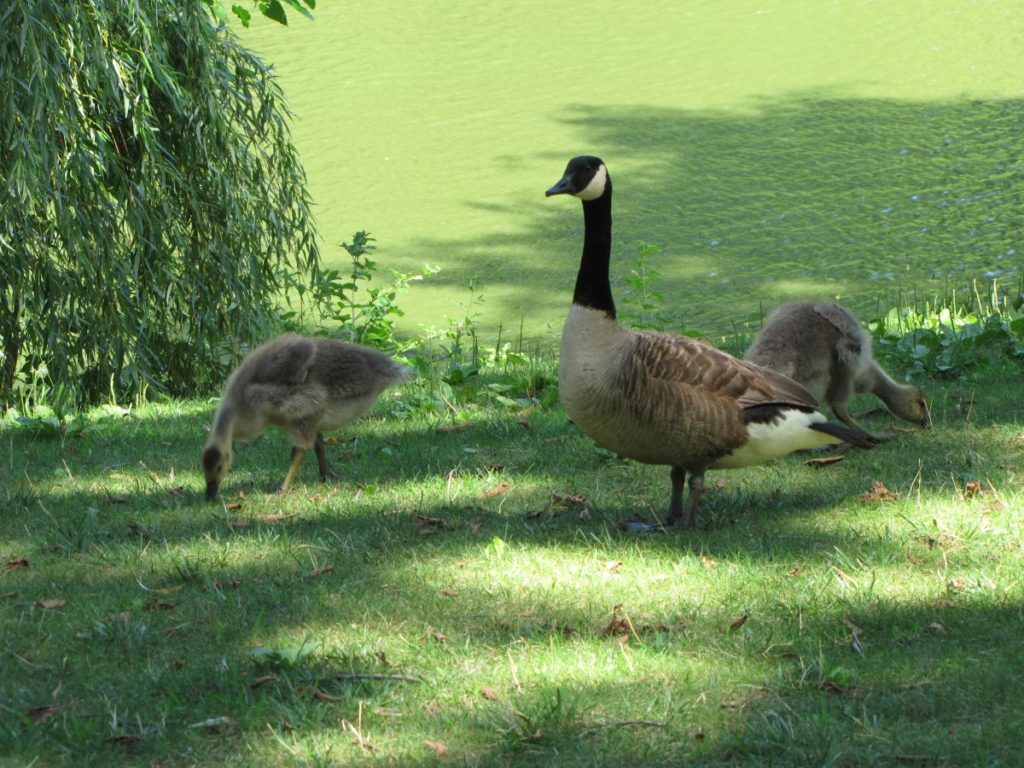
left=743, top=301, right=930, bottom=441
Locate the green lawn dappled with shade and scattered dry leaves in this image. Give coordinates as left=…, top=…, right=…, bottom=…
left=0, top=374, right=1024, bottom=766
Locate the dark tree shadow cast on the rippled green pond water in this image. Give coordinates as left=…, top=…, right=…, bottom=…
left=403, top=93, right=1024, bottom=335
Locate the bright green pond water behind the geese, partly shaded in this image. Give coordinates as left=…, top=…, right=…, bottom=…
left=249, top=0, right=1024, bottom=342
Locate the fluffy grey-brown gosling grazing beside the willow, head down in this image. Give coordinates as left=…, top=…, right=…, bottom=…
left=203, top=334, right=408, bottom=500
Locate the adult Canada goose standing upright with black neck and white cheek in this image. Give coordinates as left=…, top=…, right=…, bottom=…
left=547, top=157, right=868, bottom=527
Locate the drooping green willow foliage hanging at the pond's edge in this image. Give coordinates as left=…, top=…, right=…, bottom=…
left=0, top=0, right=319, bottom=409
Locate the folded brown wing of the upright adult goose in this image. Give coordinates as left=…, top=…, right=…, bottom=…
left=634, top=333, right=818, bottom=410
